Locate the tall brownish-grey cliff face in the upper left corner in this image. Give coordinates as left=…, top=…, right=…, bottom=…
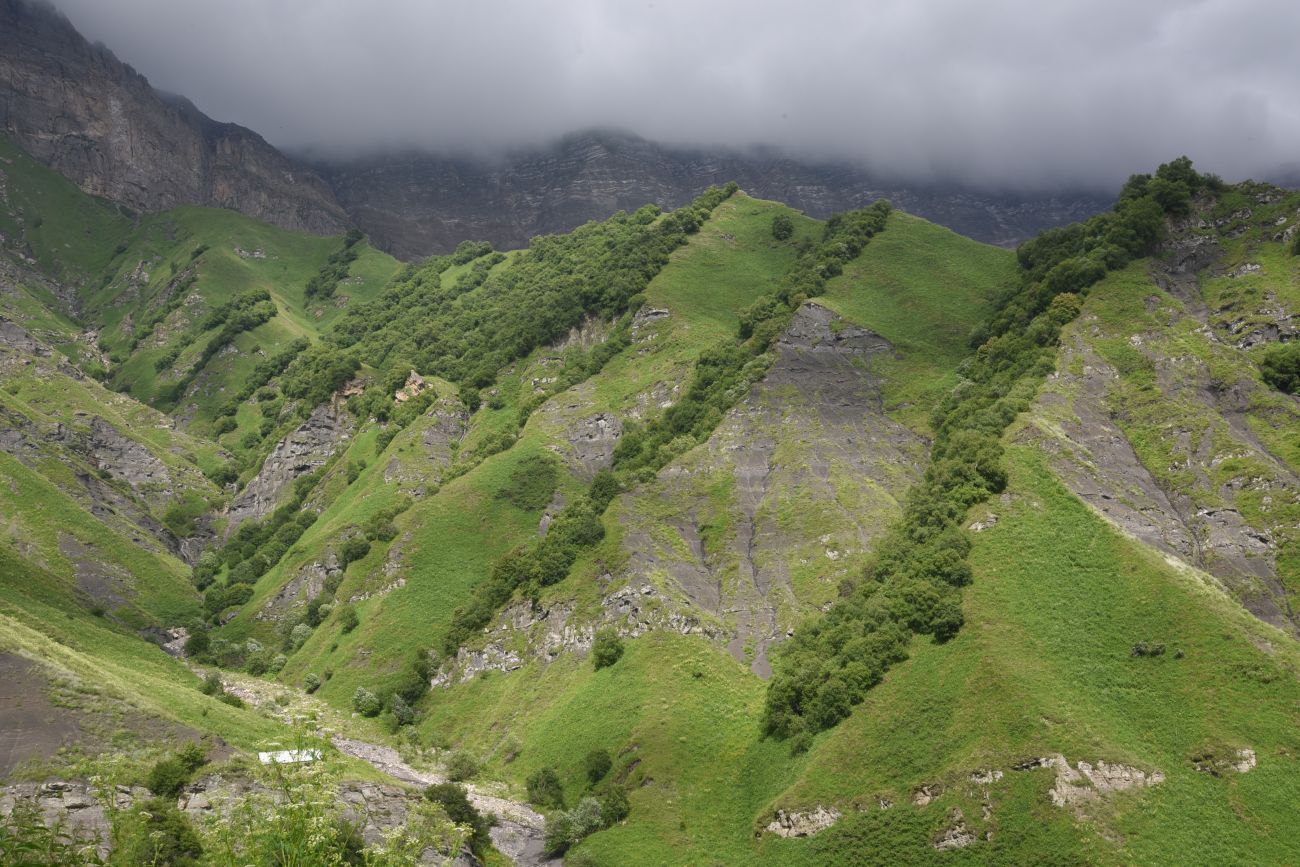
left=0, top=0, right=347, bottom=234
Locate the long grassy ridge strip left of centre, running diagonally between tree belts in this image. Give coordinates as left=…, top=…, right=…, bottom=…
left=243, top=196, right=818, bottom=705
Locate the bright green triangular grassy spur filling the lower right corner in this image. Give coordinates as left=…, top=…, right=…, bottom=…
left=774, top=446, right=1300, bottom=864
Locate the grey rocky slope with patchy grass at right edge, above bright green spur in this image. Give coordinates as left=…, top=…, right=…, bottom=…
left=1019, top=220, right=1300, bottom=634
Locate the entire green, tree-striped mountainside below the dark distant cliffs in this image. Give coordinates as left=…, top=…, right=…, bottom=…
left=0, top=116, right=1300, bottom=864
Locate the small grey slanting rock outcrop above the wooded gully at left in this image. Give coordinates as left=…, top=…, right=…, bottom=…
left=229, top=403, right=351, bottom=532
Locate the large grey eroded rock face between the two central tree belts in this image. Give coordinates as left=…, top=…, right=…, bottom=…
left=620, top=304, right=926, bottom=677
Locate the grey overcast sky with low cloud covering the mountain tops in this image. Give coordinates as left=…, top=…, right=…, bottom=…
left=48, top=0, right=1300, bottom=188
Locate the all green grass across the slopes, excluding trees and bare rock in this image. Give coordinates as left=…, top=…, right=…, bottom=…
left=0, top=142, right=1300, bottom=866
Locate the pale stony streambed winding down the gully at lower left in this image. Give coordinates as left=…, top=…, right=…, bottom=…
left=202, top=668, right=562, bottom=867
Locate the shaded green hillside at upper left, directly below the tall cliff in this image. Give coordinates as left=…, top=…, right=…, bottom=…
left=0, top=132, right=398, bottom=474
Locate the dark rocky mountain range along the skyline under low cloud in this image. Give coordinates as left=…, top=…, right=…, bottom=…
left=0, top=0, right=1109, bottom=260
